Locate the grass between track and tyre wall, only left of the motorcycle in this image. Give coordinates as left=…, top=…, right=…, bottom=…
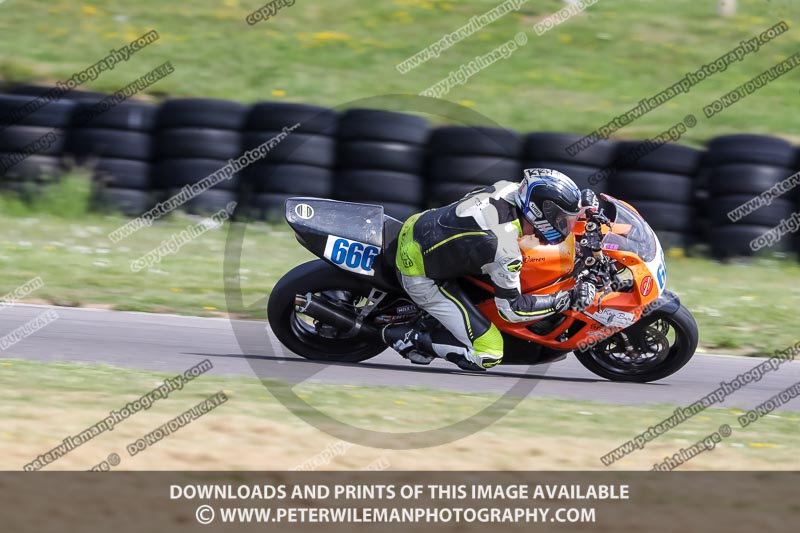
left=0, top=208, right=312, bottom=316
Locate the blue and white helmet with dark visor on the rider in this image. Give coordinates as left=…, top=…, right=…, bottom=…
left=515, top=168, right=581, bottom=244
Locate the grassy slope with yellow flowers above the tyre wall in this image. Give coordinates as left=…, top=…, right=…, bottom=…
left=0, top=0, right=800, bottom=144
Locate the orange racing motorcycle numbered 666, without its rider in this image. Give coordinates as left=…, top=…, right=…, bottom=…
left=267, top=194, right=698, bottom=383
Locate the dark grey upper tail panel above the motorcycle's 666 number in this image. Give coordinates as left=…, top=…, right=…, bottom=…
left=286, top=198, right=383, bottom=248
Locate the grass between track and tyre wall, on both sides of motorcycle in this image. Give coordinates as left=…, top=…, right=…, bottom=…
left=0, top=207, right=800, bottom=355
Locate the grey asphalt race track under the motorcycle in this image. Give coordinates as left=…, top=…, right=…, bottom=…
left=0, top=304, right=800, bottom=411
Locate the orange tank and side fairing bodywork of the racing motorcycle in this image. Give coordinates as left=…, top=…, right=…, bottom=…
left=473, top=222, right=658, bottom=350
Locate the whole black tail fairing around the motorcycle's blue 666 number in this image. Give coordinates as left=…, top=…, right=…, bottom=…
left=285, top=197, right=402, bottom=292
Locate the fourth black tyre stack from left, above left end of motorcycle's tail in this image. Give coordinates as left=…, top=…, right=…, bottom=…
left=242, top=102, right=339, bottom=220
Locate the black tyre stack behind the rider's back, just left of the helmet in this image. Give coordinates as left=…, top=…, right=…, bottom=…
left=426, top=126, right=522, bottom=207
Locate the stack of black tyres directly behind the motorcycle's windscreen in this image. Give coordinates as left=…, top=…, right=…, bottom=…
left=608, top=141, right=703, bottom=249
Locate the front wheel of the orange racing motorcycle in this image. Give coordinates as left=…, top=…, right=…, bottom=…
left=575, top=305, right=698, bottom=383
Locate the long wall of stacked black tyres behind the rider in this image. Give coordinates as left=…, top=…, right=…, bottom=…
left=0, top=85, right=800, bottom=258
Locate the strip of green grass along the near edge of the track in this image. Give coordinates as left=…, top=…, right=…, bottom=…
left=0, top=360, right=800, bottom=468
